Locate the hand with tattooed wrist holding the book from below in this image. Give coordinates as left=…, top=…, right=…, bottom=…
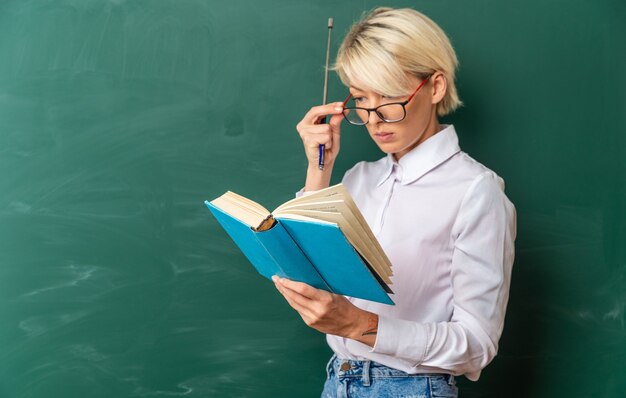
left=272, top=275, right=378, bottom=347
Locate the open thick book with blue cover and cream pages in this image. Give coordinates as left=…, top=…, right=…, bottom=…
left=205, top=184, right=393, bottom=304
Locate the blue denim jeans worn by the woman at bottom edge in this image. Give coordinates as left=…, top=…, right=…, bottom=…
left=322, top=355, right=458, bottom=398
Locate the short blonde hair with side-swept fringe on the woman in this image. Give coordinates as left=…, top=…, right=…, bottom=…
left=333, top=7, right=462, bottom=116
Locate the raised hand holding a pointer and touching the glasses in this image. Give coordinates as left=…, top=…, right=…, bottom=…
left=296, top=102, right=344, bottom=170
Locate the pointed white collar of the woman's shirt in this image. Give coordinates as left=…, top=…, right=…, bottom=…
left=377, top=125, right=461, bottom=186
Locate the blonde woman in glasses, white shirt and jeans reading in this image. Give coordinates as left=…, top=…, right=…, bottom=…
left=274, top=8, right=515, bottom=397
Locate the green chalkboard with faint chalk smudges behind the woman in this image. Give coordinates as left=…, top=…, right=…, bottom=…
left=0, top=0, right=626, bottom=398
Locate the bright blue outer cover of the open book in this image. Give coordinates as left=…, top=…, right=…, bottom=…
left=205, top=201, right=394, bottom=305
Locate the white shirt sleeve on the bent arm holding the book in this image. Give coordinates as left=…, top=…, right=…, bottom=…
left=371, top=171, right=516, bottom=380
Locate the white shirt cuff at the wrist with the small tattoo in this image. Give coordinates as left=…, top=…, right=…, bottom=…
left=370, top=315, right=429, bottom=365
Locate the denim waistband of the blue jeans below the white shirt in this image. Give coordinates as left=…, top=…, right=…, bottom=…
left=326, top=354, right=455, bottom=386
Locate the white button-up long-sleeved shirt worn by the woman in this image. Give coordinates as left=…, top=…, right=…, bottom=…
left=302, top=125, right=516, bottom=380
